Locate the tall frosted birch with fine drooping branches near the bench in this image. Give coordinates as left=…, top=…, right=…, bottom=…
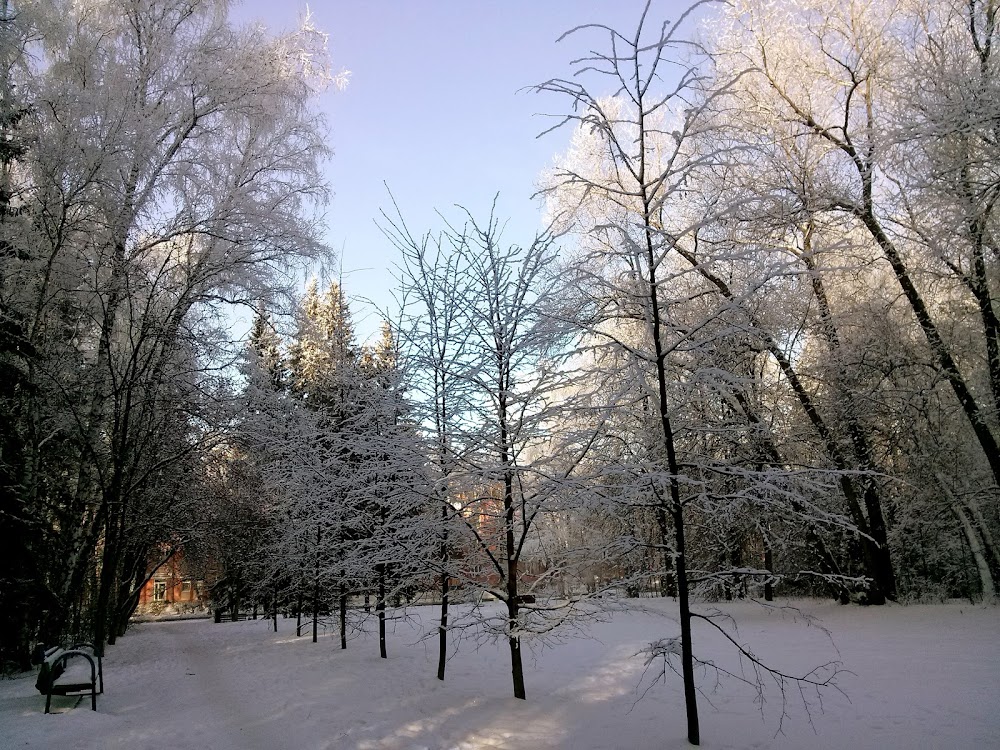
left=4, top=0, right=340, bottom=660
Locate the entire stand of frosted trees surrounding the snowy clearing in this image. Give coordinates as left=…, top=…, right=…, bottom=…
left=0, top=0, right=1000, bottom=743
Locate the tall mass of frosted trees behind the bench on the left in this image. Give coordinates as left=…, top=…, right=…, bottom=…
left=0, top=0, right=333, bottom=668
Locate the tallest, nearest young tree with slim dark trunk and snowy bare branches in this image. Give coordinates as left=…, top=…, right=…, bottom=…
left=537, top=4, right=851, bottom=744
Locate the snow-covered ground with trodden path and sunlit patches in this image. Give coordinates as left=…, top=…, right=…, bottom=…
left=0, top=601, right=1000, bottom=750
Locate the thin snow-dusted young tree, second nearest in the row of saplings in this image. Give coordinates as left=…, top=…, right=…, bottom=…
left=452, top=209, right=588, bottom=699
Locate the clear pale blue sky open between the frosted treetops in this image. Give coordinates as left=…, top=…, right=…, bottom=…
left=235, top=0, right=687, bottom=338
